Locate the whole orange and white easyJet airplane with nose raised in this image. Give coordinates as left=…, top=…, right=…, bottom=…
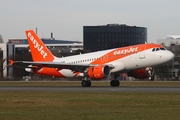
left=9, top=30, right=174, bottom=87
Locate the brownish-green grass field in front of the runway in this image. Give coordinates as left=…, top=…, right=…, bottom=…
left=0, top=91, right=180, bottom=120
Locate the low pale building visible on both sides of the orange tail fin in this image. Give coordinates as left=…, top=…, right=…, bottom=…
left=8, top=39, right=83, bottom=57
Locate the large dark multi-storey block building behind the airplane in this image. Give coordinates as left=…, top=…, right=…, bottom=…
left=83, top=24, right=147, bottom=51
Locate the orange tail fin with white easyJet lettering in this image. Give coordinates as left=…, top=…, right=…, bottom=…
left=26, top=30, right=55, bottom=62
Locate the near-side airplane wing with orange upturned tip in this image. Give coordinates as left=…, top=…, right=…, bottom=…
left=10, top=60, right=114, bottom=72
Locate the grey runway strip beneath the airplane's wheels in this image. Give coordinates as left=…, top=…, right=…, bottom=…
left=0, top=86, right=180, bottom=92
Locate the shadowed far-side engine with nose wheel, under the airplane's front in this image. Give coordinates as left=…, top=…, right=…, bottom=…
left=127, top=67, right=154, bottom=80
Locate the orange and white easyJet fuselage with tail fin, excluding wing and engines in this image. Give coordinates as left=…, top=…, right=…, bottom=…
left=23, top=30, right=174, bottom=78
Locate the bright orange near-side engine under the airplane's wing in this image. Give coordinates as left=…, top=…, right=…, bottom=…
left=87, top=65, right=110, bottom=79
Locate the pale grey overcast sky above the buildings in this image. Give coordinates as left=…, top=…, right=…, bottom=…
left=0, top=0, right=180, bottom=43
